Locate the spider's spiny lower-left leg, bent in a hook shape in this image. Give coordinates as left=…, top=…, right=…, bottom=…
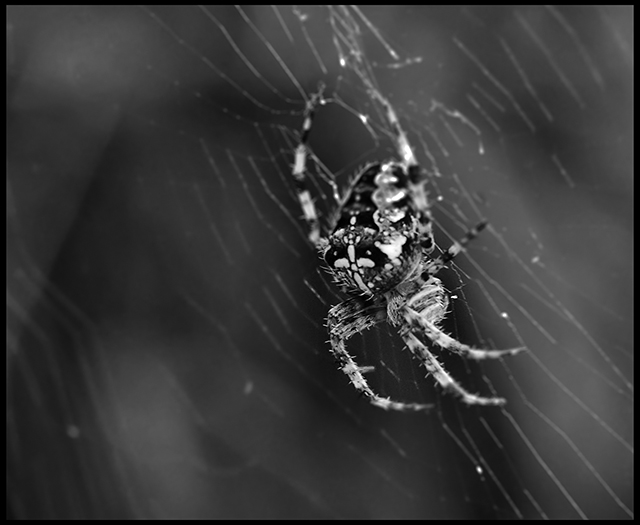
left=327, top=298, right=433, bottom=412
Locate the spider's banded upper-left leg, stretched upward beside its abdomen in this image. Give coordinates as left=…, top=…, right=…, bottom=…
left=292, top=89, right=322, bottom=248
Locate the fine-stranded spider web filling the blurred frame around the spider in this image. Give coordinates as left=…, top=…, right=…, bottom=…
left=7, top=6, right=633, bottom=518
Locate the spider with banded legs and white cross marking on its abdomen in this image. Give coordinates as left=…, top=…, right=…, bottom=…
left=292, top=89, right=524, bottom=411
